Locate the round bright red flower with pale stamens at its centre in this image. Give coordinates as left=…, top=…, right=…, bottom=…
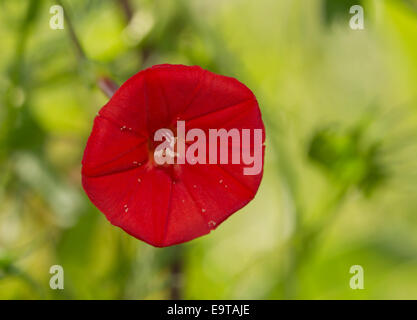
left=82, top=65, right=265, bottom=247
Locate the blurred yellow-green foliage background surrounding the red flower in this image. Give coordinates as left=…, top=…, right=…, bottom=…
left=0, top=0, right=417, bottom=299
